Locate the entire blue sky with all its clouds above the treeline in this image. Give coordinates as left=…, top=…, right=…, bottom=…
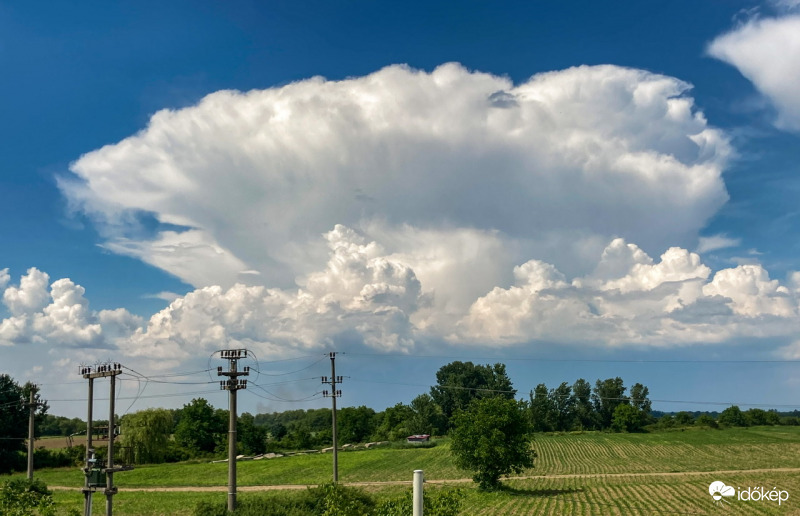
left=0, top=0, right=800, bottom=415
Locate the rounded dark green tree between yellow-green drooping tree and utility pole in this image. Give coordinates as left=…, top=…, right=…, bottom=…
left=175, top=398, right=228, bottom=455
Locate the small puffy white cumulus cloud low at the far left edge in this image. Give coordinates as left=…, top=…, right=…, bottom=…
left=0, top=268, right=142, bottom=348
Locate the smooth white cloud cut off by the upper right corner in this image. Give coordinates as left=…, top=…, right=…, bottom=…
left=708, top=15, right=800, bottom=131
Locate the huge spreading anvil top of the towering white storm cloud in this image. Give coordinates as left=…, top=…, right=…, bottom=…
left=61, top=64, right=729, bottom=290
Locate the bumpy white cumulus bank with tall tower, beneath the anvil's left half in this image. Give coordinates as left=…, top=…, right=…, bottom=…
left=124, top=225, right=425, bottom=358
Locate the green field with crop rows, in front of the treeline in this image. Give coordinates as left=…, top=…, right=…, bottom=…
left=14, top=427, right=800, bottom=515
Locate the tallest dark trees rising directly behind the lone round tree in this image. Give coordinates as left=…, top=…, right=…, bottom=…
left=431, top=361, right=517, bottom=422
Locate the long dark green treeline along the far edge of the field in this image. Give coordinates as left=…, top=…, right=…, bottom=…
left=7, top=361, right=800, bottom=470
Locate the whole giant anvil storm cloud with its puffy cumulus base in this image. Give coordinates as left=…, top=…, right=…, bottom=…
left=0, top=64, right=798, bottom=363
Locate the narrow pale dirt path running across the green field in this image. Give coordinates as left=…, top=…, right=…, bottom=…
left=48, top=468, right=800, bottom=493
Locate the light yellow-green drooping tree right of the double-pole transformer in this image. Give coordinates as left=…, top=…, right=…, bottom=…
left=120, top=409, right=172, bottom=464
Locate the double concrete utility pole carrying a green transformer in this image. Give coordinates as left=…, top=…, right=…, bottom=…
left=80, top=363, right=133, bottom=516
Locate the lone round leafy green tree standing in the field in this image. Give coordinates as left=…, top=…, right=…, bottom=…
left=450, top=397, right=535, bottom=490
